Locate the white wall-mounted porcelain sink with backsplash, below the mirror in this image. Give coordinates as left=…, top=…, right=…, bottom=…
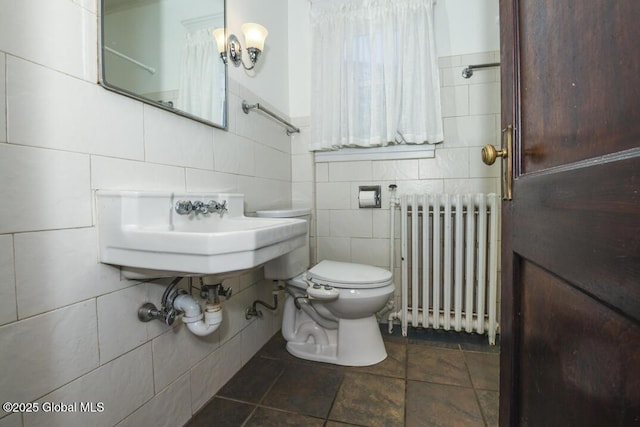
left=96, top=190, right=307, bottom=278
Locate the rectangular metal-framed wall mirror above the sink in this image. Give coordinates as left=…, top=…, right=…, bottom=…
left=100, top=0, right=227, bottom=129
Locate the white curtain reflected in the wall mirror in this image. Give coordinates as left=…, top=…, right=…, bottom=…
left=176, top=29, right=225, bottom=122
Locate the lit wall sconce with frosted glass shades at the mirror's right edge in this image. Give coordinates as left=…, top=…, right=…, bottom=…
left=213, top=23, right=269, bottom=70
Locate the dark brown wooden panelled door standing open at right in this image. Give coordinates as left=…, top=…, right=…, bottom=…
left=500, top=0, right=640, bottom=426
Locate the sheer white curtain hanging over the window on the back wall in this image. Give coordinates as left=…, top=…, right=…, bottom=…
left=311, top=0, right=443, bottom=151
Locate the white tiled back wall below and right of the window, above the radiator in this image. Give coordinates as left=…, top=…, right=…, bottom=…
left=302, top=52, right=500, bottom=314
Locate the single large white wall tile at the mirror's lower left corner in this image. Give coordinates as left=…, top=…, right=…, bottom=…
left=7, top=55, right=144, bottom=160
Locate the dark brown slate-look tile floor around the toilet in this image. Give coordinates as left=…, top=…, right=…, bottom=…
left=188, top=328, right=499, bottom=427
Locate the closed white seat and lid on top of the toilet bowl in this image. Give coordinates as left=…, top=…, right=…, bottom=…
left=306, top=260, right=392, bottom=289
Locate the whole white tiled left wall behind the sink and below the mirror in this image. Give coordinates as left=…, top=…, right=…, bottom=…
left=0, top=0, right=292, bottom=427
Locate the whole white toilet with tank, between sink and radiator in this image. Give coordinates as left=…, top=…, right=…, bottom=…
left=257, top=209, right=395, bottom=366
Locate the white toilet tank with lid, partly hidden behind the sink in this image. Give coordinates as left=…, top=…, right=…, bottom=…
left=256, top=208, right=311, bottom=280
